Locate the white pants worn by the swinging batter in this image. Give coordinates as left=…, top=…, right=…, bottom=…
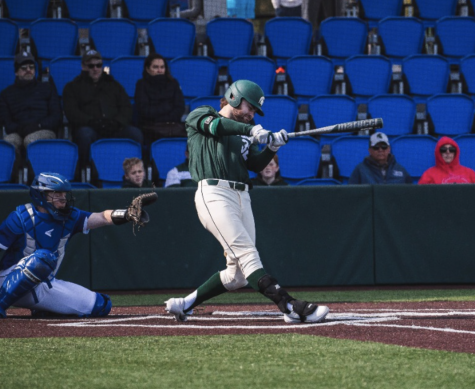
left=195, top=180, right=263, bottom=290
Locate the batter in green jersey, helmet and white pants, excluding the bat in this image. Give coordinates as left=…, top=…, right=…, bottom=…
left=165, top=80, right=329, bottom=323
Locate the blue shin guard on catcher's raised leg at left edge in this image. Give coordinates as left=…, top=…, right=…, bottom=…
left=0, top=249, right=58, bottom=316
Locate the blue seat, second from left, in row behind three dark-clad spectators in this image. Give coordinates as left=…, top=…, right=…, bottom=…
left=30, top=19, right=79, bottom=67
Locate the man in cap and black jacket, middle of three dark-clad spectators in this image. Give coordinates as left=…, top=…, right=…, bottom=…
left=63, top=50, right=143, bottom=167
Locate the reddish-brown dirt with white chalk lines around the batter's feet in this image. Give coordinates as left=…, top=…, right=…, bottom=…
left=0, top=302, right=475, bottom=353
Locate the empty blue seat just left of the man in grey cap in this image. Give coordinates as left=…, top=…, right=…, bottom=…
left=332, top=135, right=369, bottom=184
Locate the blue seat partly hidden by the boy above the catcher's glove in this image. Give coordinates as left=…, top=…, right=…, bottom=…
left=91, top=138, right=142, bottom=188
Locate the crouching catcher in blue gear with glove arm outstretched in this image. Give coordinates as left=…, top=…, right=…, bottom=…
left=0, top=173, right=157, bottom=318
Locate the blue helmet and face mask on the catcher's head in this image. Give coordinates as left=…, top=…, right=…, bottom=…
left=30, top=173, right=74, bottom=221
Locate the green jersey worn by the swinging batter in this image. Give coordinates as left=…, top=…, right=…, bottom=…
left=185, top=105, right=275, bottom=183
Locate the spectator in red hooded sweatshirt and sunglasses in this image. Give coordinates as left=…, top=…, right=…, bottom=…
left=419, top=136, right=475, bottom=184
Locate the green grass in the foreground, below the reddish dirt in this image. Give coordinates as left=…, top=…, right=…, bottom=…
left=0, top=334, right=475, bottom=389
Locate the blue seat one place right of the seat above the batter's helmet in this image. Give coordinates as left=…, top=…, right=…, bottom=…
left=287, top=55, right=333, bottom=105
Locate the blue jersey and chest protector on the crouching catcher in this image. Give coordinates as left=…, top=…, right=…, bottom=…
left=0, top=204, right=91, bottom=274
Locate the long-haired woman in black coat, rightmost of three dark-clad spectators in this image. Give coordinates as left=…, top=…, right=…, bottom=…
left=135, top=53, right=186, bottom=144
